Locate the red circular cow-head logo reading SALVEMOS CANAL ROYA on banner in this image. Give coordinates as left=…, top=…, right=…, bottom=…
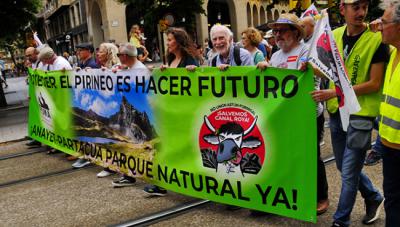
left=199, top=107, right=265, bottom=175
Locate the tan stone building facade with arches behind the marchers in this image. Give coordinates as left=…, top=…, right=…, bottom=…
left=41, top=0, right=322, bottom=53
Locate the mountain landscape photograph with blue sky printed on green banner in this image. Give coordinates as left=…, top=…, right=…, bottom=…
left=72, top=76, right=157, bottom=144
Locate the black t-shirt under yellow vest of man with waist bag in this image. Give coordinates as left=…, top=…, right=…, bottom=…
left=342, top=28, right=390, bottom=64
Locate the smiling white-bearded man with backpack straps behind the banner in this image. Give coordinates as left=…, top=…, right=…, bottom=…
left=209, top=24, right=254, bottom=70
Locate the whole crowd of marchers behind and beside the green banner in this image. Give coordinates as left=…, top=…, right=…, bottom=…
left=25, top=0, right=400, bottom=227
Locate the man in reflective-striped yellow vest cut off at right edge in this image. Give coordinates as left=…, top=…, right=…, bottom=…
left=377, top=0, right=400, bottom=227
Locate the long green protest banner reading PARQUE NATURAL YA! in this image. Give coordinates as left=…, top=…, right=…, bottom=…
left=29, top=67, right=317, bottom=223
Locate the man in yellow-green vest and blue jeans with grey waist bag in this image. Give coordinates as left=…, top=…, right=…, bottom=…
left=313, top=0, right=389, bottom=226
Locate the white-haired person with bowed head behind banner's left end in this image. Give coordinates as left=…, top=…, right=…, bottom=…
left=39, top=46, right=72, bottom=71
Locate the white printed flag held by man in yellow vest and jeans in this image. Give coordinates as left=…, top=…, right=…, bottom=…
left=309, top=10, right=361, bottom=131
